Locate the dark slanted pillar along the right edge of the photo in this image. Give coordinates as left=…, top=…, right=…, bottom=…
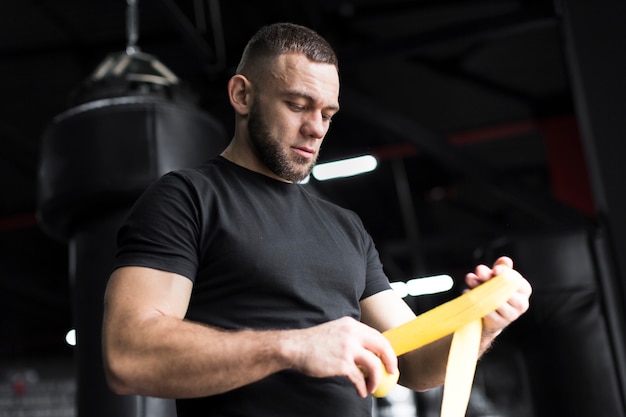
left=558, top=0, right=626, bottom=403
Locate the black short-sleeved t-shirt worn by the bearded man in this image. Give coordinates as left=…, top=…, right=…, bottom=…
left=116, top=157, right=389, bottom=417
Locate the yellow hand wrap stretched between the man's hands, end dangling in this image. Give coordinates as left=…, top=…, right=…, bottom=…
left=373, top=269, right=522, bottom=417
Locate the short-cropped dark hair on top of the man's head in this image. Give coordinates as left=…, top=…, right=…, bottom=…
left=237, top=23, right=338, bottom=75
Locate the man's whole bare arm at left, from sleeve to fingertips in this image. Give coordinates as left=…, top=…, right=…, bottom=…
left=103, top=267, right=395, bottom=398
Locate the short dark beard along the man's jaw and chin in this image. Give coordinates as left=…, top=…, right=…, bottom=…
left=248, top=102, right=317, bottom=182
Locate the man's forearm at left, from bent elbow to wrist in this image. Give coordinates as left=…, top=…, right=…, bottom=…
left=104, top=316, right=290, bottom=398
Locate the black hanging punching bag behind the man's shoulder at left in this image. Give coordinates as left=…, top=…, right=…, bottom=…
left=38, top=51, right=226, bottom=417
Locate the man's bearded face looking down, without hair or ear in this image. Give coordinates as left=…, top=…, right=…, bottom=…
left=248, top=54, right=339, bottom=182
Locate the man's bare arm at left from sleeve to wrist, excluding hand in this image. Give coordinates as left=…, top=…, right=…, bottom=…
left=103, top=267, right=288, bottom=398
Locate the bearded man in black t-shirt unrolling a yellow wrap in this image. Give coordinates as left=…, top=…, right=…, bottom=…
left=103, top=24, right=531, bottom=417
